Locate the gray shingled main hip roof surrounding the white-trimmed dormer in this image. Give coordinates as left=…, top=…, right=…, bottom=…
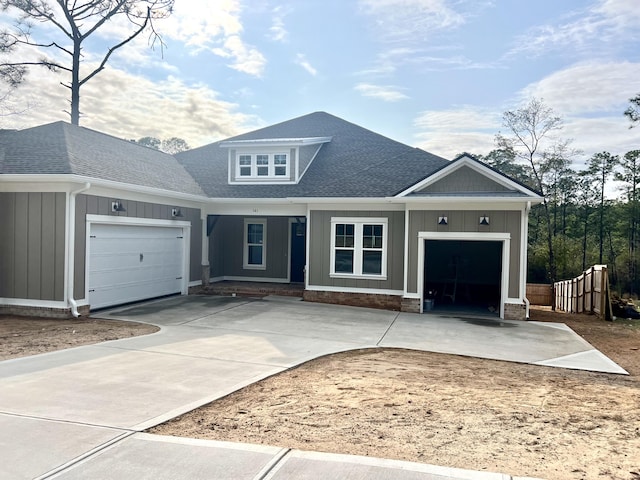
left=176, top=112, right=448, bottom=198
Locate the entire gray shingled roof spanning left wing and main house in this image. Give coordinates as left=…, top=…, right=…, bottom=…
left=0, top=112, right=449, bottom=198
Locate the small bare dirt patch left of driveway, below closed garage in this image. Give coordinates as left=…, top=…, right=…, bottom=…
left=0, top=315, right=159, bottom=360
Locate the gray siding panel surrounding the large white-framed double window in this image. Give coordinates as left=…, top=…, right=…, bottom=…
left=308, top=210, right=404, bottom=291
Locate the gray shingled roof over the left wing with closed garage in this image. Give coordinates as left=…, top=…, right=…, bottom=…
left=0, top=122, right=204, bottom=196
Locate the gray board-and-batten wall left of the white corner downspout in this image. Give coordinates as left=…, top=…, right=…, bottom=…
left=0, top=192, right=66, bottom=301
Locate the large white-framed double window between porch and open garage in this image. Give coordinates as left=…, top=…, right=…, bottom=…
left=331, top=217, right=387, bottom=279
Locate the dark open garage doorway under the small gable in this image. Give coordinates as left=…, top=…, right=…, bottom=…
left=424, top=240, right=503, bottom=316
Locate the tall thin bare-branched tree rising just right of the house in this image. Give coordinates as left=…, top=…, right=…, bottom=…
left=496, top=98, right=572, bottom=292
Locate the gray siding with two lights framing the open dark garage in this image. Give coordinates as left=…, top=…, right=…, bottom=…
left=407, top=210, right=521, bottom=298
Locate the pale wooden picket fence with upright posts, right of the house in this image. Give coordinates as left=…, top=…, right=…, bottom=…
left=554, top=265, right=613, bottom=320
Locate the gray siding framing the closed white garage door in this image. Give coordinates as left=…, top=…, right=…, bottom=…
left=74, top=194, right=202, bottom=299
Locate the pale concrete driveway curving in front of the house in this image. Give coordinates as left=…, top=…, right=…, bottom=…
left=0, top=296, right=626, bottom=480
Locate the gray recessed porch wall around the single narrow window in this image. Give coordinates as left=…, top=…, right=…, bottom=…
left=209, top=215, right=289, bottom=280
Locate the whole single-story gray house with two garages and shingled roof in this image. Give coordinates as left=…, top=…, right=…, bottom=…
left=0, top=112, right=542, bottom=319
